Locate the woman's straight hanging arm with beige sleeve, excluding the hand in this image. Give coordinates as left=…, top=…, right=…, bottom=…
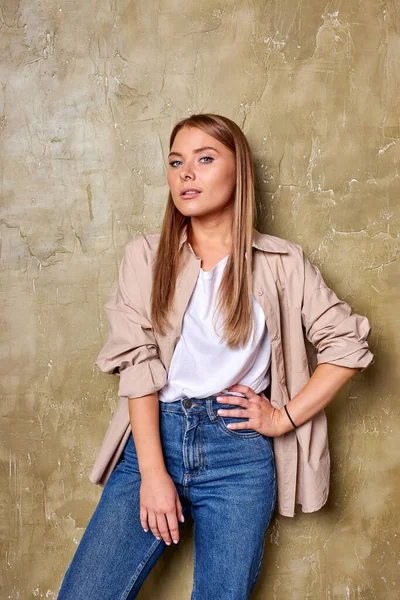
left=96, top=238, right=167, bottom=472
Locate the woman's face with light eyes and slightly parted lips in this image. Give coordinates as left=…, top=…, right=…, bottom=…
left=168, top=127, right=236, bottom=217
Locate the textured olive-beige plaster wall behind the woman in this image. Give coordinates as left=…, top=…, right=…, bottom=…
left=0, top=0, right=400, bottom=600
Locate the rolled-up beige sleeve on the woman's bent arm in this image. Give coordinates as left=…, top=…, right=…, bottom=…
left=302, top=252, right=375, bottom=371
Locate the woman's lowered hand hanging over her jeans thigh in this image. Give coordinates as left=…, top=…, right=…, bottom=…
left=140, top=469, right=185, bottom=545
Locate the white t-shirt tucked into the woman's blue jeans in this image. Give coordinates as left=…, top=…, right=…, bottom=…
left=159, top=255, right=271, bottom=402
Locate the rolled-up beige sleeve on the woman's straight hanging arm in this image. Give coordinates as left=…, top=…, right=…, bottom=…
left=96, top=240, right=167, bottom=398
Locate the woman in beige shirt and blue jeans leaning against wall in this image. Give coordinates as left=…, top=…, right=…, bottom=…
left=59, top=114, right=373, bottom=600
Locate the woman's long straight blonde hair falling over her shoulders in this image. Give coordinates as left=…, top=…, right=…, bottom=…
left=151, top=114, right=256, bottom=348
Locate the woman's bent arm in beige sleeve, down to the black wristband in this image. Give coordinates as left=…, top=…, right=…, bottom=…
left=279, top=248, right=374, bottom=435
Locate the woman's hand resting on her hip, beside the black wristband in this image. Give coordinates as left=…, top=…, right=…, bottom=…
left=218, top=383, right=284, bottom=437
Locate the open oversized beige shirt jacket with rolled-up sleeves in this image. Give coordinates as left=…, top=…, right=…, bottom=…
left=90, top=229, right=374, bottom=517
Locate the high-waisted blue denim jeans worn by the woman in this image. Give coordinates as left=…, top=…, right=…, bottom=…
left=58, top=396, right=277, bottom=600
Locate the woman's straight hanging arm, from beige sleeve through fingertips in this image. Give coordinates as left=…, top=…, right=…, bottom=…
left=96, top=238, right=183, bottom=544
